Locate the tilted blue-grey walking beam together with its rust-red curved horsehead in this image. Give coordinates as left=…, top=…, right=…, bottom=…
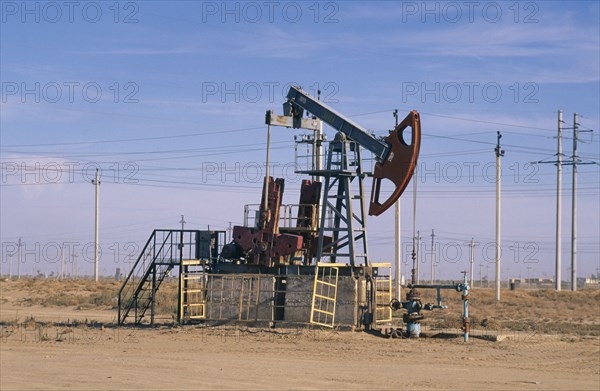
left=283, top=86, right=421, bottom=216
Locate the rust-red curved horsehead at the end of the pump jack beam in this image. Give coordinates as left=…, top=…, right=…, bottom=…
left=369, top=110, right=421, bottom=216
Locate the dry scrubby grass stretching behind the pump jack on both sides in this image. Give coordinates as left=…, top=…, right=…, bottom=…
left=0, top=278, right=600, bottom=336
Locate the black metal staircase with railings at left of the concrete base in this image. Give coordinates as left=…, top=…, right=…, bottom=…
left=118, top=229, right=225, bottom=325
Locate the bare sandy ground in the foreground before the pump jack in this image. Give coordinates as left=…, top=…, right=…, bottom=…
left=0, top=280, right=600, bottom=391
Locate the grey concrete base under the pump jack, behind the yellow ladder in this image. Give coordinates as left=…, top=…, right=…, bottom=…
left=188, top=267, right=392, bottom=329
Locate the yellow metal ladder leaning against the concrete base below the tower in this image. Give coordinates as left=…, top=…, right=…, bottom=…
left=310, top=262, right=346, bottom=328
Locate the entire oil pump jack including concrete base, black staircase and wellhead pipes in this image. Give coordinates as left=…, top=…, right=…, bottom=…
left=118, top=87, right=470, bottom=334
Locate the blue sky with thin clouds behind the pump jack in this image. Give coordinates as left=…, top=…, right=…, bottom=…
left=0, top=1, right=600, bottom=280
